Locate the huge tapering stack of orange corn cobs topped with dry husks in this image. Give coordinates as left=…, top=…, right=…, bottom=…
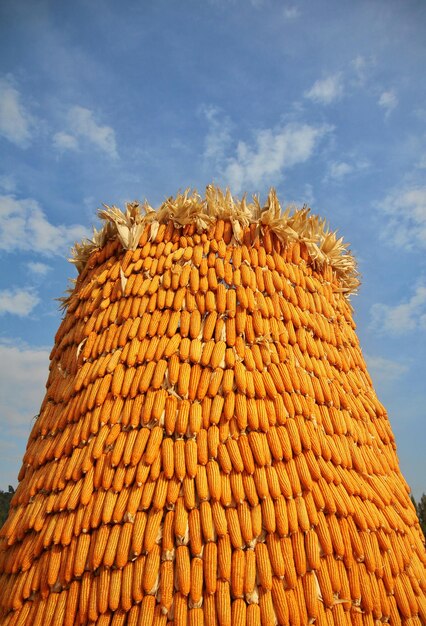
left=0, top=188, right=426, bottom=626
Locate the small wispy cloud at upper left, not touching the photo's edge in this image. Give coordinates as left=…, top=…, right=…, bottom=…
left=53, top=106, right=118, bottom=159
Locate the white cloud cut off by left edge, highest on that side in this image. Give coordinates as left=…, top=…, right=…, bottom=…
left=0, top=78, right=33, bottom=148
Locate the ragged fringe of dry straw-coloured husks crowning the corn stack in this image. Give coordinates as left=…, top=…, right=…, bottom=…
left=70, top=185, right=359, bottom=294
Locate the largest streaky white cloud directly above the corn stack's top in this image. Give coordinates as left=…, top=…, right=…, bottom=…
left=223, top=123, right=331, bottom=193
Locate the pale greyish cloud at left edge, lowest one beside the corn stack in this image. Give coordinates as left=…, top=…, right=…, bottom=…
left=0, top=342, right=49, bottom=430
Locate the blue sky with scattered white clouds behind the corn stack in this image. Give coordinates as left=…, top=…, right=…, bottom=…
left=0, top=0, right=426, bottom=497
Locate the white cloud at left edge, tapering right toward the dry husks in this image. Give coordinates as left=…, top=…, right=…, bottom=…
left=0, top=195, right=87, bottom=255
